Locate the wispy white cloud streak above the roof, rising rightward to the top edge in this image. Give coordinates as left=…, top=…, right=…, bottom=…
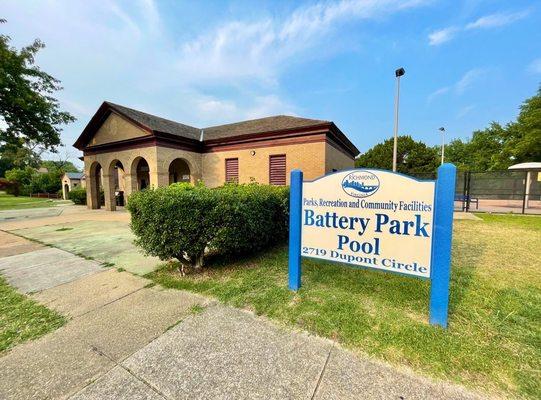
left=177, top=0, right=425, bottom=83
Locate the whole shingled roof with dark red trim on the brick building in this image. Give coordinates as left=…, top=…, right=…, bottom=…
left=74, top=101, right=359, bottom=156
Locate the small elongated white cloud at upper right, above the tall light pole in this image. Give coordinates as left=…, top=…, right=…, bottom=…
left=428, top=10, right=530, bottom=46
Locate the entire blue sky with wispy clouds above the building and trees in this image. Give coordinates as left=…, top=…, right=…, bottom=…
left=0, top=0, right=541, bottom=164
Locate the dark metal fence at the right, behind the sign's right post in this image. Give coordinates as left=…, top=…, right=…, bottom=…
left=411, top=170, right=541, bottom=214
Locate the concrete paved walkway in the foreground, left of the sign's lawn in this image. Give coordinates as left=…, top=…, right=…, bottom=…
left=0, top=216, right=486, bottom=400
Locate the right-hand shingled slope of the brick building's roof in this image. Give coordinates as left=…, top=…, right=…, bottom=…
left=203, top=115, right=330, bottom=140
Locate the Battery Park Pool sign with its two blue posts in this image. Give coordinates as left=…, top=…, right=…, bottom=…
left=289, top=164, right=456, bottom=328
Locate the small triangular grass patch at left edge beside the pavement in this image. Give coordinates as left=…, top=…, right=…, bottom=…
left=0, top=277, right=66, bottom=355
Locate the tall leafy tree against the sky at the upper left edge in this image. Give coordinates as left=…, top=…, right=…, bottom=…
left=0, top=20, right=75, bottom=151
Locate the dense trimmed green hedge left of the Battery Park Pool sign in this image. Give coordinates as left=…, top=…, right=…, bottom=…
left=127, top=183, right=289, bottom=269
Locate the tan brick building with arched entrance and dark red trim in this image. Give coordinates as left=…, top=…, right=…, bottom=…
left=74, top=102, right=359, bottom=210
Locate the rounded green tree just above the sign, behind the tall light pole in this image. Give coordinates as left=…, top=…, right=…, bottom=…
left=355, top=136, right=438, bottom=174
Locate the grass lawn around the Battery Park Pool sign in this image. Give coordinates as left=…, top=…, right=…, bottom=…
left=150, top=214, right=541, bottom=399
